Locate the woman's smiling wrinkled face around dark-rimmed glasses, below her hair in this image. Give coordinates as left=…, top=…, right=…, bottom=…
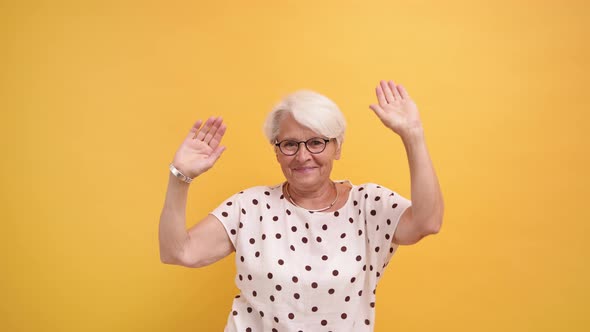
left=275, top=114, right=340, bottom=189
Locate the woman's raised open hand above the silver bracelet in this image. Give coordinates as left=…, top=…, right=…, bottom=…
left=172, top=117, right=226, bottom=178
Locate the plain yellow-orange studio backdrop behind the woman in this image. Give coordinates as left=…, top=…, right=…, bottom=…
left=0, top=0, right=590, bottom=332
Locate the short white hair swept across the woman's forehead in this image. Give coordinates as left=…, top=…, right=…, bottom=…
left=264, top=90, right=346, bottom=146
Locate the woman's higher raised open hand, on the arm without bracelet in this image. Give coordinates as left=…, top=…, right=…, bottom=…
left=369, top=81, right=422, bottom=139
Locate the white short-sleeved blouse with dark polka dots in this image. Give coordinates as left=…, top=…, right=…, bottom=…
left=212, top=183, right=411, bottom=332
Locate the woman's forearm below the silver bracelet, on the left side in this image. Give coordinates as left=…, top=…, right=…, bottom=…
left=159, top=174, right=189, bottom=264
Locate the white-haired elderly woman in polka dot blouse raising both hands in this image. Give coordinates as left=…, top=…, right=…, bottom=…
left=160, top=81, right=443, bottom=332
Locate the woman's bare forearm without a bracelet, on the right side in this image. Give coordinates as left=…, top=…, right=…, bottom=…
left=402, top=128, right=444, bottom=234
